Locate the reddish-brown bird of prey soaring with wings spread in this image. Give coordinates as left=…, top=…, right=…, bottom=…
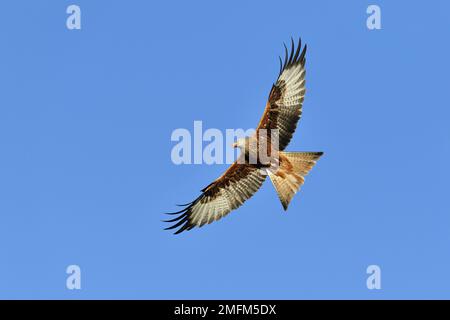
left=165, top=39, right=323, bottom=234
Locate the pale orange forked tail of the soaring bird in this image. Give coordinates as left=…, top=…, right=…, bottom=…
left=268, top=152, right=323, bottom=210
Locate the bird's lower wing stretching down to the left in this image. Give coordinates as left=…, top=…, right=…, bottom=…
left=165, top=162, right=266, bottom=234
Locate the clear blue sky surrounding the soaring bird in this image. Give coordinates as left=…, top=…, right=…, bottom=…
left=0, top=0, right=450, bottom=299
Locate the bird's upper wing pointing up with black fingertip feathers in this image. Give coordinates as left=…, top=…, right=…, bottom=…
left=257, top=39, right=306, bottom=150
